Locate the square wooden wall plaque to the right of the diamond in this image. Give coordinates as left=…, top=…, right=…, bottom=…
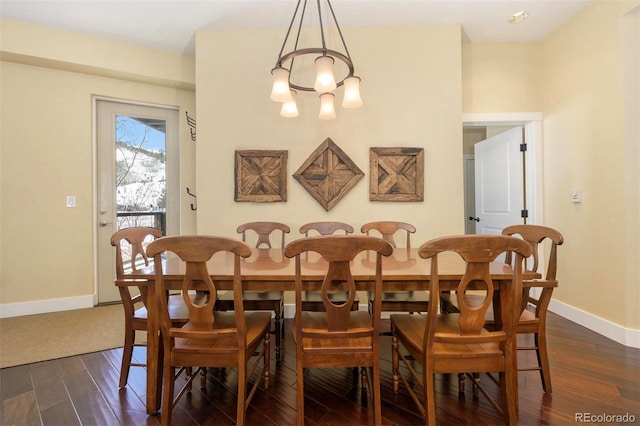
left=369, top=148, right=424, bottom=202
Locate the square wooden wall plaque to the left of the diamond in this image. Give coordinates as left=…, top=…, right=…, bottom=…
left=235, top=150, right=288, bottom=203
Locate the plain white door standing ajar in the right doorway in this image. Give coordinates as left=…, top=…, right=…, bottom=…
left=476, top=126, right=525, bottom=235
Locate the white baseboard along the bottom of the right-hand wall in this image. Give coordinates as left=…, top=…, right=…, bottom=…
left=549, top=299, right=640, bottom=348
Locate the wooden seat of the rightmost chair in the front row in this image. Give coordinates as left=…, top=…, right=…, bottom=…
left=391, top=314, right=503, bottom=360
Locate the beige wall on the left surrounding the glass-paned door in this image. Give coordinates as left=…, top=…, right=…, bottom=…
left=0, top=21, right=195, bottom=312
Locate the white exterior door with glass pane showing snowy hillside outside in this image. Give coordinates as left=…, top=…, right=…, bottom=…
left=96, top=100, right=180, bottom=303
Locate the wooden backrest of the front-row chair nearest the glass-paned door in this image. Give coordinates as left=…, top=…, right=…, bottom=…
left=147, top=235, right=251, bottom=347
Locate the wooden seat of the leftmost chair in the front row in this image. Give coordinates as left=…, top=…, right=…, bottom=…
left=169, top=312, right=271, bottom=354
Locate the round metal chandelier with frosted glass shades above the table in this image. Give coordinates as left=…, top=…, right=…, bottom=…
left=271, top=0, right=362, bottom=120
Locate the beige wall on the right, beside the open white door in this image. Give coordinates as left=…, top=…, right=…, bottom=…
left=541, top=1, right=640, bottom=330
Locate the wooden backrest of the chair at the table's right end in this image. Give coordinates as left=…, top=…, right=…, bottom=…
left=502, top=225, right=564, bottom=281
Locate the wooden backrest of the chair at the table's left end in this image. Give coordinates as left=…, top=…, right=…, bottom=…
left=111, top=227, right=162, bottom=279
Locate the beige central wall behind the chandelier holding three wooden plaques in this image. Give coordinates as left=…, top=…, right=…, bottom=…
left=196, top=25, right=464, bottom=246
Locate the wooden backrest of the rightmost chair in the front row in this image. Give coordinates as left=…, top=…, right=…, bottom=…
left=418, top=235, right=531, bottom=352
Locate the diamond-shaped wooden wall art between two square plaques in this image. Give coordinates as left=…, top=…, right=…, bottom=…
left=293, top=138, right=364, bottom=211
